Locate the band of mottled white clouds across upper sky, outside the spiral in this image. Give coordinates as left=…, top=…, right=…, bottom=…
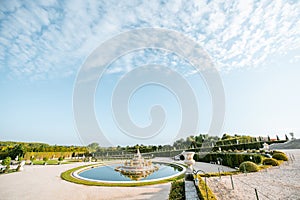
left=0, top=0, right=300, bottom=79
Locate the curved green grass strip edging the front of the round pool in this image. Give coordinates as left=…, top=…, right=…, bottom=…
left=60, top=164, right=184, bottom=187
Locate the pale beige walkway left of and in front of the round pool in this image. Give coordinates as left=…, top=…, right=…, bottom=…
left=0, top=163, right=171, bottom=200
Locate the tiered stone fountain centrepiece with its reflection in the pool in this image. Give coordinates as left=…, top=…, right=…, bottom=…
left=115, top=149, right=158, bottom=180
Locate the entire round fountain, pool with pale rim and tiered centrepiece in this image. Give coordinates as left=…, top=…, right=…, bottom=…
left=70, top=150, right=186, bottom=186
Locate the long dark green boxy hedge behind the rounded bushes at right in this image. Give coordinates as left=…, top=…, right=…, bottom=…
left=194, top=152, right=263, bottom=168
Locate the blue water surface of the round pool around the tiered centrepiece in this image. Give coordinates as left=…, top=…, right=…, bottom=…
left=79, top=163, right=182, bottom=181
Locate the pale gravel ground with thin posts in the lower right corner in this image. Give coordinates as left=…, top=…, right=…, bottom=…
left=207, top=149, right=300, bottom=200
